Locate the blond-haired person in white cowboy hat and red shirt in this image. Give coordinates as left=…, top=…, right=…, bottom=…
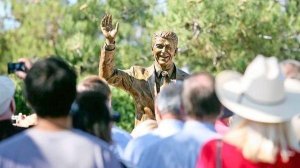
left=197, top=55, right=300, bottom=168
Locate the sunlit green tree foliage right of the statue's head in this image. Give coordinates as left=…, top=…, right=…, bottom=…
left=152, top=0, right=300, bottom=72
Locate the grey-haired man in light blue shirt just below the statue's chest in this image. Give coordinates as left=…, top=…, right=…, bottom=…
left=124, top=81, right=185, bottom=166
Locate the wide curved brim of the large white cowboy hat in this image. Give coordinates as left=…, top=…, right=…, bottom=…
left=216, top=71, right=300, bottom=123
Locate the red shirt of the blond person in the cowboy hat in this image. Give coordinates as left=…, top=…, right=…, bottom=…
left=196, top=140, right=300, bottom=168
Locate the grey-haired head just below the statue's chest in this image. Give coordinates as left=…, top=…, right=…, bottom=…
left=155, top=81, right=184, bottom=119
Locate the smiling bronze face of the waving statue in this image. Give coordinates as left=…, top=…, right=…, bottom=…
left=152, top=37, right=177, bottom=66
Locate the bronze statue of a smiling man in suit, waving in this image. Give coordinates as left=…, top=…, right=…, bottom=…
left=99, top=15, right=188, bottom=125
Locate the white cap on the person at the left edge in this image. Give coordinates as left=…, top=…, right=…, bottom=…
left=0, top=76, right=15, bottom=115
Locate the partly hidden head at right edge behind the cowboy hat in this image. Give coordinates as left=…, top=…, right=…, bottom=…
left=281, top=59, right=300, bottom=80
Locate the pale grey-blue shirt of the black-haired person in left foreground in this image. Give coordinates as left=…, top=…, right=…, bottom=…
left=0, top=128, right=121, bottom=168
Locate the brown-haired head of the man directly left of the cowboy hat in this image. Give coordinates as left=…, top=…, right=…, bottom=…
left=182, top=72, right=221, bottom=121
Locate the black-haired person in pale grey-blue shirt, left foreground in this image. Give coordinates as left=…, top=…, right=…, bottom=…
left=0, top=57, right=120, bottom=168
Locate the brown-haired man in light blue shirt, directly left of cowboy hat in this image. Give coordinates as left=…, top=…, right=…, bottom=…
left=137, top=72, right=221, bottom=168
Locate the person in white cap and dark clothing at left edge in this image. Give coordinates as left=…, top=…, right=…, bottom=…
left=0, top=75, right=23, bottom=141
